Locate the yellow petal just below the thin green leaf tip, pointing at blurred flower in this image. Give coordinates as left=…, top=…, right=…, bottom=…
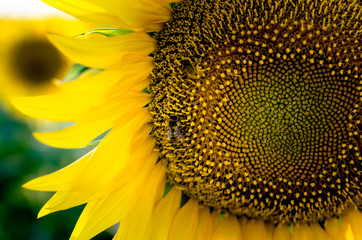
left=49, top=32, right=156, bottom=68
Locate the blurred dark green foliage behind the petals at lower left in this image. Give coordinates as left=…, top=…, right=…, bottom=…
left=0, top=107, right=112, bottom=240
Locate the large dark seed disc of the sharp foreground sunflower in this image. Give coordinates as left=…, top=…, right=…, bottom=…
left=150, top=0, right=362, bottom=223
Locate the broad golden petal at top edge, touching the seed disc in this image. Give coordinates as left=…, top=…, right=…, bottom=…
left=85, top=0, right=172, bottom=32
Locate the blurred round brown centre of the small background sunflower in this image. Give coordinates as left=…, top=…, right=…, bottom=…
left=11, top=39, right=64, bottom=85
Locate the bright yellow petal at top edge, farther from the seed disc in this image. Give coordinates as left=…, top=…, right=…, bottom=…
left=42, top=0, right=124, bottom=27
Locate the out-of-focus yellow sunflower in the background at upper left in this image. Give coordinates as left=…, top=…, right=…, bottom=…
left=0, top=18, right=94, bottom=100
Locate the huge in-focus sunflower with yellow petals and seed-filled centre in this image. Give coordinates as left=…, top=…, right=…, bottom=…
left=13, top=0, right=362, bottom=240
